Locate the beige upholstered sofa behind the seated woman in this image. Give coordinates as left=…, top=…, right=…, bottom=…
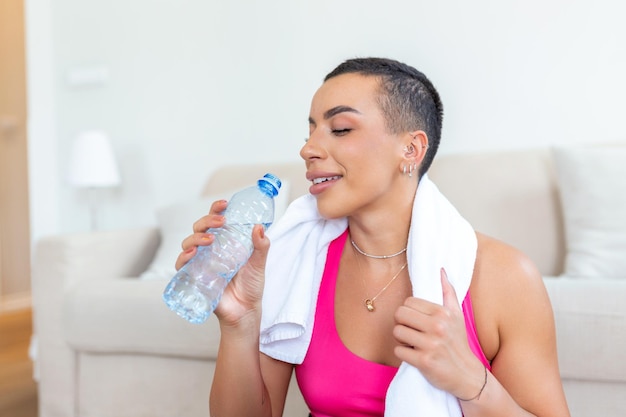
left=33, top=148, right=626, bottom=417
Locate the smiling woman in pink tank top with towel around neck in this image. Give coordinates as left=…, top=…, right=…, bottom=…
left=176, top=58, right=569, bottom=417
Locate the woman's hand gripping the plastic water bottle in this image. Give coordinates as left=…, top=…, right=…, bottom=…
left=176, top=200, right=270, bottom=326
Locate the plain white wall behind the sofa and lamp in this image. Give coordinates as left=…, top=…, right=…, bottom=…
left=26, top=0, right=626, bottom=239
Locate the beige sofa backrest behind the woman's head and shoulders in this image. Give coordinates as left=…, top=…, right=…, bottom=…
left=202, top=148, right=565, bottom=276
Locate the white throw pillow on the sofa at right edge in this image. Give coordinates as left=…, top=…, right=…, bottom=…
left=554, top=146, right=626, bottom=279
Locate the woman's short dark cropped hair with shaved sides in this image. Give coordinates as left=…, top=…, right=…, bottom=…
left=324, top=58, right=443, bottom=177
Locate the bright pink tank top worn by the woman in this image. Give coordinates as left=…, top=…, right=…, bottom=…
left=296, top=230, right=490, bottom=417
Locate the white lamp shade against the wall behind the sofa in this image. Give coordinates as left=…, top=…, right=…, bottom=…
left=68, top=130, right=120, bottom=187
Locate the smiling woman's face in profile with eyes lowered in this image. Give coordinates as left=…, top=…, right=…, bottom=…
left=300, top=74, right=410, bottom=218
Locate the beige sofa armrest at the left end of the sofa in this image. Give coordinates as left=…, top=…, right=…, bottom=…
left=32, top=228, right=160, bottom=415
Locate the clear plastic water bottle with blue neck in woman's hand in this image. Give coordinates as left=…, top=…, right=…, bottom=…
left=163, top=174, right=281, bottom=323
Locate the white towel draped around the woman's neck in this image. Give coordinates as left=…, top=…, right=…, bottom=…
left=260, top=175, right=477, bottom=417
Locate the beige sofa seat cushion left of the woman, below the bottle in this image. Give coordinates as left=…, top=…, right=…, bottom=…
left=63, top=278, right=220, bottom=360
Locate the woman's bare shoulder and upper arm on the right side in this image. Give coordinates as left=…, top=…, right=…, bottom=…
left=471, top=234, right=568, bottom=416
